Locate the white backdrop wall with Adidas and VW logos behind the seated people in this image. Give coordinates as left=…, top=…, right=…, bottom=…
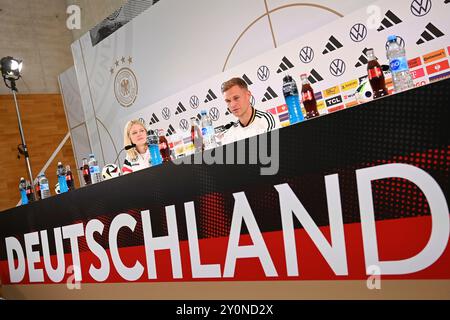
left=63, top=0, right=450, bottom=169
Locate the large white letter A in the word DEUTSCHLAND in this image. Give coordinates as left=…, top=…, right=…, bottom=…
left=223, top=192, right=278, bottom=278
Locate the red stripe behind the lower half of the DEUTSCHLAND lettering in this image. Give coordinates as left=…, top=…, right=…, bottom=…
left=0, top=216, right=450, bottom=285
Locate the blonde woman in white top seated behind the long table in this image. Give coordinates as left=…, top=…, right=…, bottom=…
left=122, top=120, right=150, bottom=174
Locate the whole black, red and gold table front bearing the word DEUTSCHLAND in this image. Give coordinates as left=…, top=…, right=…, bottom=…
left=0, top=80, right=450, bottom=299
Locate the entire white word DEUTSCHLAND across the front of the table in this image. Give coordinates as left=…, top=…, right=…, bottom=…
left=5, top=164, right=450, bottom=282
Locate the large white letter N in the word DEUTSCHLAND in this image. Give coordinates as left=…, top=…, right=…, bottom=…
left=275, top=174, right=348, bottom=276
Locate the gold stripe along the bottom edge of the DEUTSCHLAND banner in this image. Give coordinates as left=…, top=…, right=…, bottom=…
left=3, top=279, right=450, bottom=300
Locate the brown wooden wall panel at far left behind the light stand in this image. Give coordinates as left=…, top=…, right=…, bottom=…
left=0, top=94, right=79, bottom=211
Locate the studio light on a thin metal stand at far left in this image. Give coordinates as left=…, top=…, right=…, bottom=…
left=0, top=57, right=37, bottom=200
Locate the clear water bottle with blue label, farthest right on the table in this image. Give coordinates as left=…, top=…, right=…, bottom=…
left=386, top=35, right=414, bottom=92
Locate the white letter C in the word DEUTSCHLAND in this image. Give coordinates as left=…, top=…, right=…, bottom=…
left=109, top=213, right=144, bottom=281
